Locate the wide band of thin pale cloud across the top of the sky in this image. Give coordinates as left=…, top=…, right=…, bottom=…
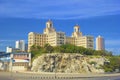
left=0, top=0, right=120, bottom=19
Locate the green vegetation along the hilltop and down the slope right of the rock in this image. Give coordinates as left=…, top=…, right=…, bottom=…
left=31, top=44, right=120, bottom=72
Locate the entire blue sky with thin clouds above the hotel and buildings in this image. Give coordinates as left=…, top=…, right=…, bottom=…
left=0, top=0, right=120, bottom=55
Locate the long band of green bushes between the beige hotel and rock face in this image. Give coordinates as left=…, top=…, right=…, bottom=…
left=31, top=44, right=112, bottom=58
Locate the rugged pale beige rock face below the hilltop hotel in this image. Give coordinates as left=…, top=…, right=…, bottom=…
left=31, top=53, right=106, bottom=73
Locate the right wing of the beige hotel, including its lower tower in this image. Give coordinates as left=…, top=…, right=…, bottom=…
left=66, top=25, right=94, bottom=49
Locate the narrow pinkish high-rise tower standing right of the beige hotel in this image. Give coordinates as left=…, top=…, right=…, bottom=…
left=96, top=36, right=105, bottom=50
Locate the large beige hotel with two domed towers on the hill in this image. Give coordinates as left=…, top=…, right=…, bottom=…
left=28, top=20, right=94, bottom=52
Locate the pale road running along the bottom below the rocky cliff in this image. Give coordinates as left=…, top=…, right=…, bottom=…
left=0, top=72, right=120, bottom=80
